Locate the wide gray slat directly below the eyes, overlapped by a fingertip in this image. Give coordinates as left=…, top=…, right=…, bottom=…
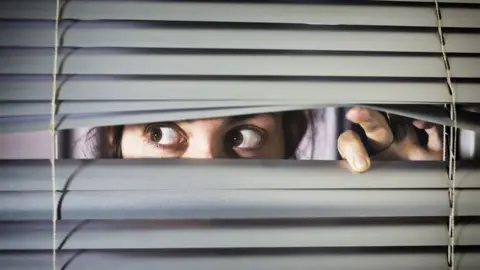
left=0, top=159, right=480, bottom=191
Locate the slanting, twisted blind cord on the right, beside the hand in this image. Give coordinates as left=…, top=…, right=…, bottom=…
left=435, top=0, right=457, bottom=270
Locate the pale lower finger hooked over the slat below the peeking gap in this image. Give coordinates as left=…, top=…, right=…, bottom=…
left=337, top=130, right=370, bottom=173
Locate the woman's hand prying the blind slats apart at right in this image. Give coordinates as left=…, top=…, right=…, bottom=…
left=337, top=107, right=443, bottom=173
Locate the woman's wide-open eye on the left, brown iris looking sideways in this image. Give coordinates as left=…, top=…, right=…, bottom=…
left=145, top=124, right=187, bottom=147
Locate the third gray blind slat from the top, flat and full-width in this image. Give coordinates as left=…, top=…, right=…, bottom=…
left=0, top=48, right=480, bottom=78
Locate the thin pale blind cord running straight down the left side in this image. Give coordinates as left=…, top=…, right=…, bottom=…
left=49, top=0, right=60, bottom=270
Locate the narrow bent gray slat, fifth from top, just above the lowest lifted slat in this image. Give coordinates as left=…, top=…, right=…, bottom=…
left=0, top=100, right=480, bottom=125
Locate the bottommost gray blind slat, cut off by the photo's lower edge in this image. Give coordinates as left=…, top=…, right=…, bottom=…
left=0, top=249, right=480, bottom=270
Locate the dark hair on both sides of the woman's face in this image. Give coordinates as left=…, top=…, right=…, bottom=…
left=87, top=111, right=312, bottom=159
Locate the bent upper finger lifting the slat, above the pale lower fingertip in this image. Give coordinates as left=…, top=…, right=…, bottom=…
left=346, top=107, right=393, bottom=150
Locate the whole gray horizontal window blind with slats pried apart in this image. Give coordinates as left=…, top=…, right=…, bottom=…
left=0, top=0, right=480, bottom=270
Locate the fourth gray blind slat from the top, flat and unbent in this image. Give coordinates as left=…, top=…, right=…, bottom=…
left=4, top=79, right=472, bottom=103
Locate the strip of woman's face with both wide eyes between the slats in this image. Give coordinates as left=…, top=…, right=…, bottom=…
left=121, top=113, right=285, bottom=159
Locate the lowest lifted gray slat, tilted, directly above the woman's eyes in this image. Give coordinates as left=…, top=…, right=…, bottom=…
left=4, top=103, right=480, bottom=132
